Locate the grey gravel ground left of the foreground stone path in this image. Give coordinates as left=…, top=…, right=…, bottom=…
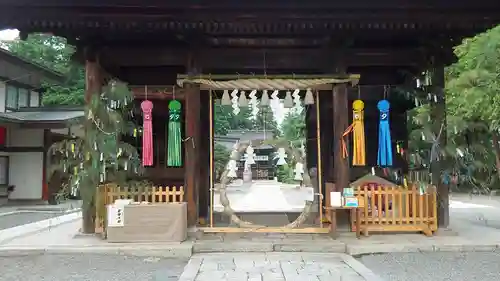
left=0, top=254, right=187, bottom=281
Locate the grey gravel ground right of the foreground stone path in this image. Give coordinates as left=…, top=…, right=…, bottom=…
left=359, top=251, right=500, bottom=281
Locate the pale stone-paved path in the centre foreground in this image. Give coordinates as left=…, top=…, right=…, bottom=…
left=179, top=253, right=380, bottom=281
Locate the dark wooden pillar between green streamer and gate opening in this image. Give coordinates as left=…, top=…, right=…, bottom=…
left=184, top=83, right=201, bottom=225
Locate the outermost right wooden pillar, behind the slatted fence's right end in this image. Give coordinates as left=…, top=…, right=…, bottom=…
left=431, top=64, right=450, bottom=228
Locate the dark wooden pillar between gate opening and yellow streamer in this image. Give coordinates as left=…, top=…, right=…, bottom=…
left=333, top=83, right=349, bottom=191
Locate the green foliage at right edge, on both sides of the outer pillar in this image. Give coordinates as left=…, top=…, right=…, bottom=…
left=408, top=26, right=500, bottom=190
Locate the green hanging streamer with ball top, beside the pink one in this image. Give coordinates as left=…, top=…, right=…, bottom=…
left=167, top=100, right=182, bottom=167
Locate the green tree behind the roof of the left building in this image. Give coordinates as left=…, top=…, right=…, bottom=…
left=4, top=34, right=85, bottom=105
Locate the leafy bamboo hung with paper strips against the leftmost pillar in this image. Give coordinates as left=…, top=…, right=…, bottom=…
left=48, top=81, right=141, bottom=233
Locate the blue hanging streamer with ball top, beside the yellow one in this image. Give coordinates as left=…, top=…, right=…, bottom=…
left=377, top=100, right=392, bottom=166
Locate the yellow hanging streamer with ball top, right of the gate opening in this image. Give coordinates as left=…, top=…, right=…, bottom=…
left=342, top=100, right=366, bottom=166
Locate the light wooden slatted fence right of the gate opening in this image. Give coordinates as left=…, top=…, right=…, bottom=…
left=351, top=185, right=437, bottom=236
